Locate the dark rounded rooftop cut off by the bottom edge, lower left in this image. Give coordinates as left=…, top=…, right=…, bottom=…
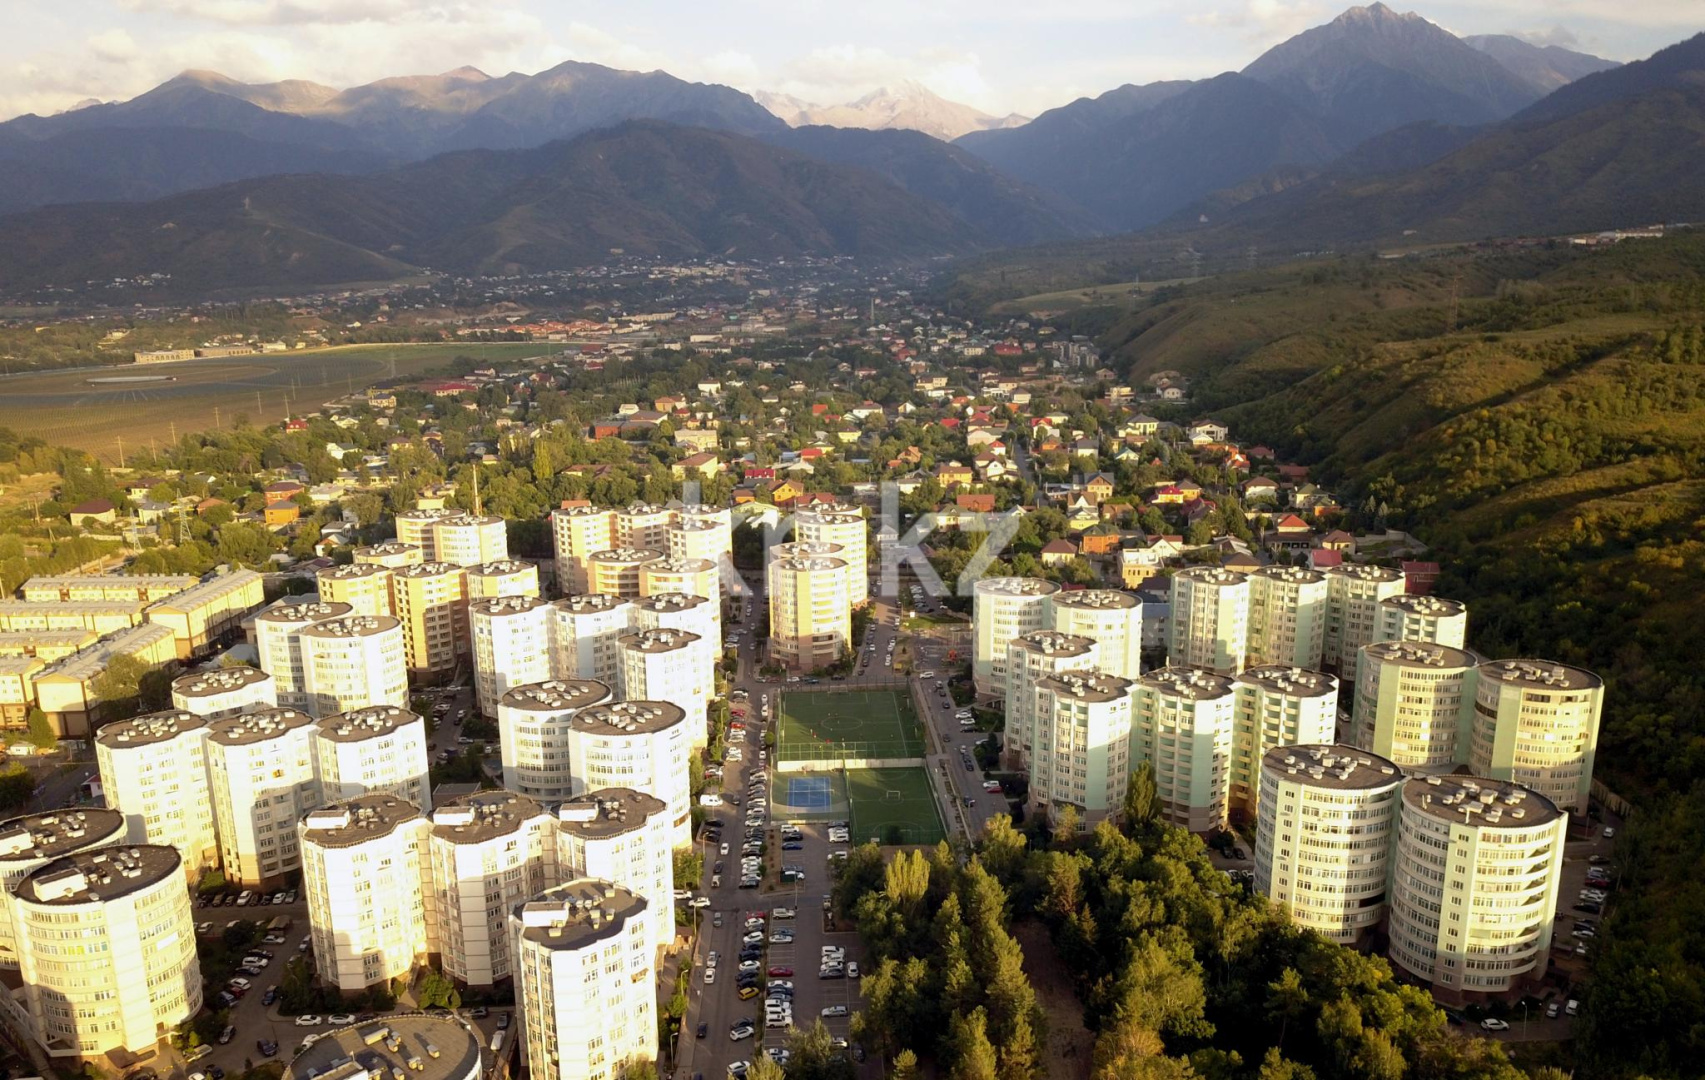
left=285, top=1013, right=483, bottom=1080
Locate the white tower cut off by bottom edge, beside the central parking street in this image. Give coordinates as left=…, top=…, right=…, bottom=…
left=510, top=879, right=656, bottom=1080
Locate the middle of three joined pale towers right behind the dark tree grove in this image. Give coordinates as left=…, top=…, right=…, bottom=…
left=1130, top=667, right=1238, bottom=833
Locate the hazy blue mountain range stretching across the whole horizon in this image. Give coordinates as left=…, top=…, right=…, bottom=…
left=0, top=3, right=1705, bottom=288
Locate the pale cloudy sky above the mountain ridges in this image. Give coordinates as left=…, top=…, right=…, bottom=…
left=0, top=0, right=1705, bottom=118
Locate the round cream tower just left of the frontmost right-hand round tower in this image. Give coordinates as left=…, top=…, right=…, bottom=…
left=1255, top=742, right=1403, bottom=945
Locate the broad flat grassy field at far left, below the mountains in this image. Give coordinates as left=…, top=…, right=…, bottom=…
left=0, top=341, right=552, bottom=453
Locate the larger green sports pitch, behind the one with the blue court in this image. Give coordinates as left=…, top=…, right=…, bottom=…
left=776, top=689, right=924, bottom=761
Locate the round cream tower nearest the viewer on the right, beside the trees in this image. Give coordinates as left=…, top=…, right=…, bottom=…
left=1386, top=775, right=1569, bottom=1002
